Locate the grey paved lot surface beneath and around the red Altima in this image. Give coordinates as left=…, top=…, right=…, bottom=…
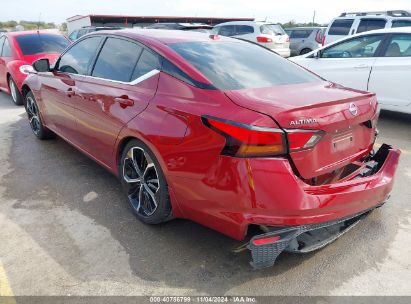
left=0, top=92, right=411, bottom=296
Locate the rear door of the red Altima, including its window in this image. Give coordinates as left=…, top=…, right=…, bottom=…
left=71, top=37, right=160, bottom=167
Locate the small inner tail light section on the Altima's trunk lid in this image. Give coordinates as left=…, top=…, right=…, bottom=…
left=286, top=130, right=323, bottom=152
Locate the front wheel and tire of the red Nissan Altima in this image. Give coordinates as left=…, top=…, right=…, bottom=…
left=25, top=92, right=55, bottom=140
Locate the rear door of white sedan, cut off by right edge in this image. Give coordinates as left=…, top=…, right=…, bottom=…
left=369, top=33, right=411, bottom=111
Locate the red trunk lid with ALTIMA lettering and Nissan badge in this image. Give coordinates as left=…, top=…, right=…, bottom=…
left=225, top=81, right=377, bottom=179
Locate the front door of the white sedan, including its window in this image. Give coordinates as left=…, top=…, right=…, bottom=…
left=307, top=34, right=384, bottom=91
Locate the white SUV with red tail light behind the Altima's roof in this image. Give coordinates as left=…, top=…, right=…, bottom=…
left=212, top=21, right=290, bottom=57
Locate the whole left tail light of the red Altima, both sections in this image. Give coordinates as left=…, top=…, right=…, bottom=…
left=202, top=116, right=323, bottom=157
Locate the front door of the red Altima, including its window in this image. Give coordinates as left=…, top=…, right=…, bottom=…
left=39, top=36, right=102, bottom=144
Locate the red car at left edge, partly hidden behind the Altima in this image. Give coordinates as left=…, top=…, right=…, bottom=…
left=0, top=31, right=70, bottom=105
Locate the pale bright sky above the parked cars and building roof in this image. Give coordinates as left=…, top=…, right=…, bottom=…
left=0, top=0, right=411, bottom=23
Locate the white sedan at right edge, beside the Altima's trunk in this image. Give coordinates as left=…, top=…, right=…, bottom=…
left=291, top=27, right=411, bottom=114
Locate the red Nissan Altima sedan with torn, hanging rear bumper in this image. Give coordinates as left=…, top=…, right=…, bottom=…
left=23, top=30, right=400, bottom=267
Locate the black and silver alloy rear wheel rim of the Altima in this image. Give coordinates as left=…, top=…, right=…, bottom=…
left=123, top=147, right=160, bottom=217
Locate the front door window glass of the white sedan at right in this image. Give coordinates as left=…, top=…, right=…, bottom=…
left=321, top=35, right=384, bottom=58
